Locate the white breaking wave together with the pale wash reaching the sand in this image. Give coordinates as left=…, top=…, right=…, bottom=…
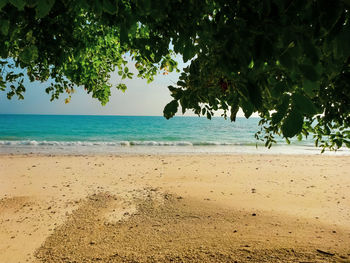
left=0, top=140, right=350, bottom=156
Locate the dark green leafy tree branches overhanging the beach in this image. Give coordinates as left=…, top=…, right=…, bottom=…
left=0, top=0, right=350, bottom=152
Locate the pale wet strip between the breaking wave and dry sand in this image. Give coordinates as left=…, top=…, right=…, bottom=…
left=0, top=146, right=350, bottom=156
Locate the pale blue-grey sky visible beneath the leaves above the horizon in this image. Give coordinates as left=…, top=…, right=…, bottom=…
left=0, top=60, right=249, bottom=116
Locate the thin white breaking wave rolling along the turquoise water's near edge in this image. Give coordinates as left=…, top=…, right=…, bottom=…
left=0, top=140, right=247, bottom=147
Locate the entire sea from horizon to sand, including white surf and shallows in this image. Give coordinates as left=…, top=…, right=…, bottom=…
left=0, top=114, right=350, bottom=155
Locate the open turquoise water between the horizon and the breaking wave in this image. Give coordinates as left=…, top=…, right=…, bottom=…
left=0, top=115, right=258, bottom=144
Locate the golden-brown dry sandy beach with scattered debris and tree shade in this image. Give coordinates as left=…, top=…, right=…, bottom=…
left=0, top=154, right=350, bottom=263
